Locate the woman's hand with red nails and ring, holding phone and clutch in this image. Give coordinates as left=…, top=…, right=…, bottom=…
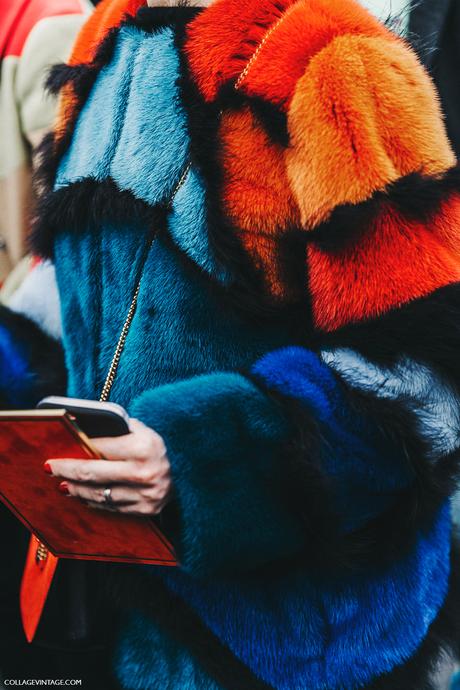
left=45, top=419, right=171, bottom=515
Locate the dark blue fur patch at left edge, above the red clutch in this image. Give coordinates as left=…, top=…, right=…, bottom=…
left=0, top=306, right=66, bottom=409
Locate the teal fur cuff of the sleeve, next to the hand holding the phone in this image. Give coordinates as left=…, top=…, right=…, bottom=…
left=130, top=373, right=303, bottom=575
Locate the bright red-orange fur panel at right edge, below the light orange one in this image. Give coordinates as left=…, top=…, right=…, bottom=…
left=308, top=204, right=460, bottom=331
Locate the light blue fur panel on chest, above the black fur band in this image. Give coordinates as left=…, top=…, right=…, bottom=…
left=56, top=27, right=189, bottom=195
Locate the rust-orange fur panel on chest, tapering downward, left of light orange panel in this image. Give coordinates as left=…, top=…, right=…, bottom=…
left=219, top=108, right=299, bottom=295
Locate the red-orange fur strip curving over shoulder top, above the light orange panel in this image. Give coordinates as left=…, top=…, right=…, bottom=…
left=241, top=0, right=390, bottom=109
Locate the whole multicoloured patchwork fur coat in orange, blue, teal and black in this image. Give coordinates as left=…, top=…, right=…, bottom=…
left=0, top=0, right=460, bottom=690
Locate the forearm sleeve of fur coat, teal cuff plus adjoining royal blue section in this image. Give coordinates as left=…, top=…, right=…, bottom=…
left=131, top=347, right=422, bottom=575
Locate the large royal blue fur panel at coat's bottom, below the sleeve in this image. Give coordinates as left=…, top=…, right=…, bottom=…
left=108, top=500, right=449, bottom=690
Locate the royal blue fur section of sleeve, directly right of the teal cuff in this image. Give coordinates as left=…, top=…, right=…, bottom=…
left=252, top=347, right=415, bottom=534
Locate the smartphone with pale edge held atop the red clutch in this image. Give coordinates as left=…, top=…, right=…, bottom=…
left=37, top=395, right=130, bottom=438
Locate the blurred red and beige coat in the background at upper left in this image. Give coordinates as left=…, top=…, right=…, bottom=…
left=0, top=0, right=92, bottom=290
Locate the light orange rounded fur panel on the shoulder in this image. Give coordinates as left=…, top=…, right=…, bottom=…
left=286, top=36, right=455, bottom=228
